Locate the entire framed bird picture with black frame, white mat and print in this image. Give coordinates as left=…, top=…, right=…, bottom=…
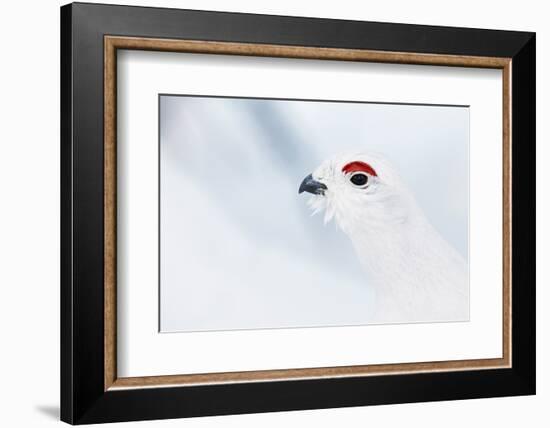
left=61, top=3, right=535, bottom=424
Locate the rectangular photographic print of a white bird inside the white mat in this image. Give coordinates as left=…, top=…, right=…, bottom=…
left=159, top=94, right=469, bottom=333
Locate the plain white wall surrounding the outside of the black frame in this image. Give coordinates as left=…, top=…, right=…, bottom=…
left=0, top=0, right=550, bottom=428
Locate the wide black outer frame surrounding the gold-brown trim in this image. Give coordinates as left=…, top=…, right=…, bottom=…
left=61, top=3, right=536, bottom=424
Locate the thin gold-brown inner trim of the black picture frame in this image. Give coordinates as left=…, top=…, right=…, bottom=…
left=104, top=36, right=512, bottom=390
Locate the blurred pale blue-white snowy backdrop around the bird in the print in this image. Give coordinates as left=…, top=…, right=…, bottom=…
left=160, top=95, right=469, bottom=332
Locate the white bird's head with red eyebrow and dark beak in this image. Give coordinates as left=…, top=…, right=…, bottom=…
left=298, top=153, right=415, bottom=233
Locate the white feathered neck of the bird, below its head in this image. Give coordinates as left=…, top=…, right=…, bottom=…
left=350, top=222, right=469, bottom=323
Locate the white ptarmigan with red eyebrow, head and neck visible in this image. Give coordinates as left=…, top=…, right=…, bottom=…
left=299, top=153, right=469, bottom=323
